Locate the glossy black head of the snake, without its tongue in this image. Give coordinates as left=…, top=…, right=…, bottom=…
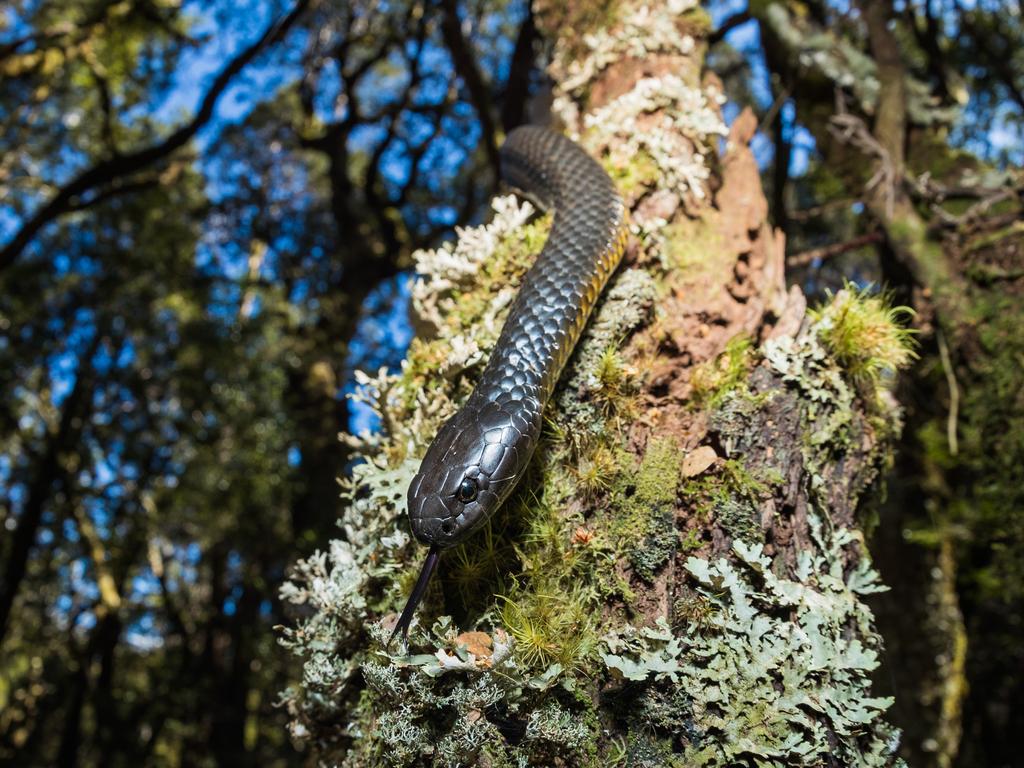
left=409, top=398, right=540, bottom=548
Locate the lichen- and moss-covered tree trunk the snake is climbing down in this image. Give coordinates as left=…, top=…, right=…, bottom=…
left=284, top=0, right=907, bottom=766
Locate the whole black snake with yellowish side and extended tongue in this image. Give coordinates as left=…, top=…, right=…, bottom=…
left=391, top=126, right=627, bottom=651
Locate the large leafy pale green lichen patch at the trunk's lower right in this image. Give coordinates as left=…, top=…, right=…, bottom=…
left=601, top=514, right=898, bottom=766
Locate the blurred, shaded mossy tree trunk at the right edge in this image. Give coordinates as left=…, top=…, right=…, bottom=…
left=752, top=0, right=1024, bottom=767
